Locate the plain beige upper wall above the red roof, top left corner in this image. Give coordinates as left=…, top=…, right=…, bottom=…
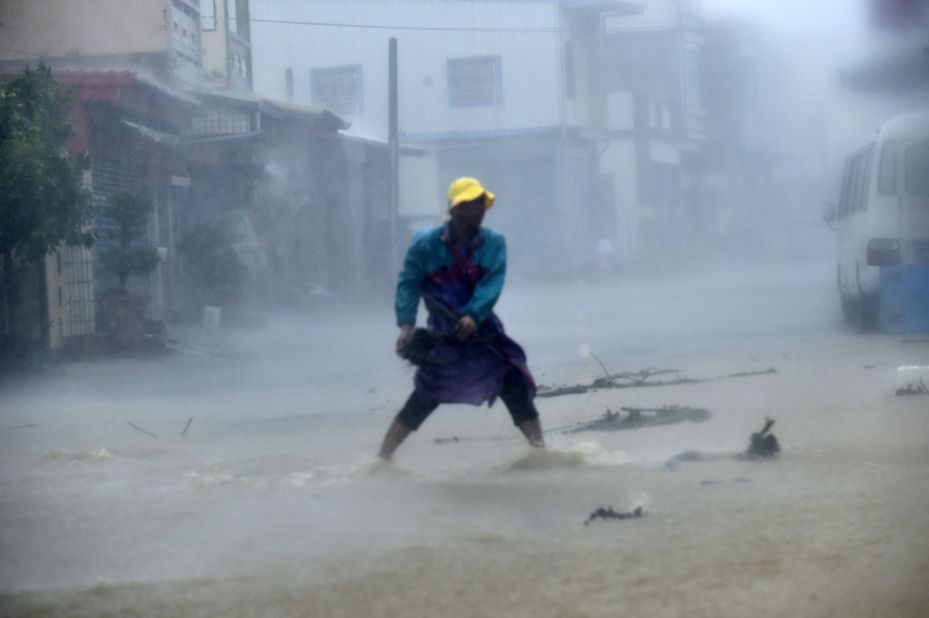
left=0, top=0, right=170, bottom=59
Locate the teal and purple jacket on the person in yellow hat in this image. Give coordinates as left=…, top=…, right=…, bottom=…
left=395, top=224, right=506, bottom=331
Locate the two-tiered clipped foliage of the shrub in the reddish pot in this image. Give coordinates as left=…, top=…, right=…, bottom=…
left=100, top=191, right=158, bottom=290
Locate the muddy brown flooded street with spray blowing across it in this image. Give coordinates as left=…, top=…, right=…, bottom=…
left=0, top=258, right=929, bottom=618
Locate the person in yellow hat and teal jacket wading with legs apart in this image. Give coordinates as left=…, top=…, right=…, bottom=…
left=378, top=178, right=545, bottom=460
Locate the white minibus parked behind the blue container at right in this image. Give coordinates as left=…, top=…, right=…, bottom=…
left=824, top=112, right=929, bottom=328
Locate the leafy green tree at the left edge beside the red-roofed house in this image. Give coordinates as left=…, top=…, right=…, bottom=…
left=0, top=64, right=93, bottom=344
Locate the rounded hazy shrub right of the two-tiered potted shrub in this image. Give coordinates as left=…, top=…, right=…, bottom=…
left=180, top=224, right=245, bottom=304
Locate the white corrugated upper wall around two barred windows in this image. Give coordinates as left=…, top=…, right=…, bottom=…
left=251, top=0, right=561, bottom=138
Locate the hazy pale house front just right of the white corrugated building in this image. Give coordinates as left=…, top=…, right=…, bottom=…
left=594, top=0, right=706, bottom=260
